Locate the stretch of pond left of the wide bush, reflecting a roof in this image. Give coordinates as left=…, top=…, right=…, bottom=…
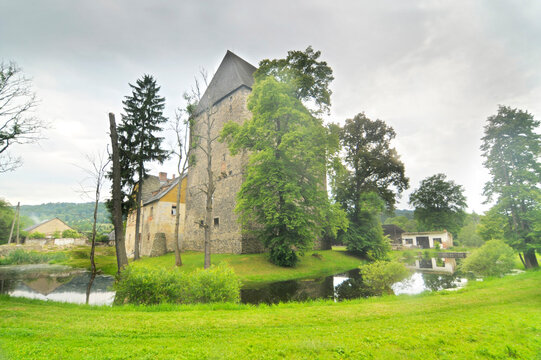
left=0, top=265, right=115, bottom=305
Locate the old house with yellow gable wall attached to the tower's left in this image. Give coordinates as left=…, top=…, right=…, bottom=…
left=125, top=172, right=186, bottom=256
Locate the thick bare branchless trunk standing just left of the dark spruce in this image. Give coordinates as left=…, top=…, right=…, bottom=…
left=109, top=113, right=128, bottom=273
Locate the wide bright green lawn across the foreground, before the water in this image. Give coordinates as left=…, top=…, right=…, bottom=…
left=0, top=271, right=541, bottom=360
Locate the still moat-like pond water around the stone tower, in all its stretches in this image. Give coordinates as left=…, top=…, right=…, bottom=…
left=0, top=259, right=466, bottom=305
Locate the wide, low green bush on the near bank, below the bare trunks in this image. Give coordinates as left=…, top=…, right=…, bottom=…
left=114, top=264, right=240, bottom=305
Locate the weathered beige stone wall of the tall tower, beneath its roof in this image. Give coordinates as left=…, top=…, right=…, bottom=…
left=182, top=87, right=262, bottom=254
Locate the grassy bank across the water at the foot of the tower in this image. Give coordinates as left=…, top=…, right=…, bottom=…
left=59, top=248, right=361, bottom=286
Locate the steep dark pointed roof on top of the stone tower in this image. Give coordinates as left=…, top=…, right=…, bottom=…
left=196, top=50, right=257, bottom=114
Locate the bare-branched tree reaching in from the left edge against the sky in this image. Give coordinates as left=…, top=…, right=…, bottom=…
left=0, top=62, right=47, bottom=173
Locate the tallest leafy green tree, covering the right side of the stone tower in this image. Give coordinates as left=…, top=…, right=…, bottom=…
left=222, top=47, right=347, bottom=266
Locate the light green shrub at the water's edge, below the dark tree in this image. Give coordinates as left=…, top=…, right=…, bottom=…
left=359, top=261, right=410, bottom=296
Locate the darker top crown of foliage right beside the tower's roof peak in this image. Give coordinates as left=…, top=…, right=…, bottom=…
left=254, top=46, right=334, bottom=114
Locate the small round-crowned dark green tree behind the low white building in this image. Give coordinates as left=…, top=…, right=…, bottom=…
left=410, top=174, right=466, bottom=237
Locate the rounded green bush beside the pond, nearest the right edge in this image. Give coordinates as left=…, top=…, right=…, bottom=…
left=461, top=240, right=515, bottom=276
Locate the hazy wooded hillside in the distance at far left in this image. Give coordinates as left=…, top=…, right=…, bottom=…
left=21, top=202, right=112, bottom=231
